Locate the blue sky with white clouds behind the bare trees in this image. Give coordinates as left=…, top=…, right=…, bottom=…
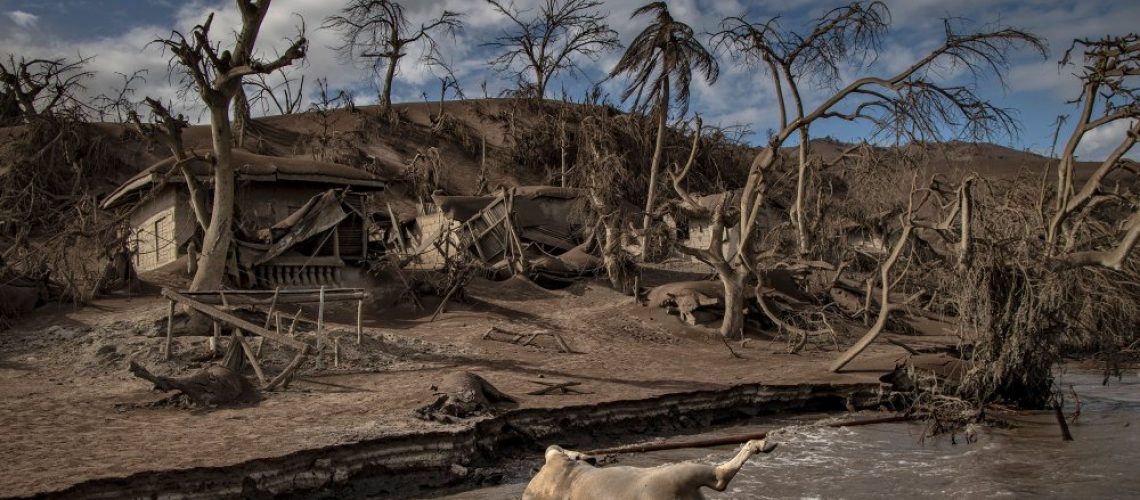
left=0, top=0, right=1140, bottom=159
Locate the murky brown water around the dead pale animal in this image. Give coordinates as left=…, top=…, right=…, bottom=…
left=437, top=372, right=1140, bottom=499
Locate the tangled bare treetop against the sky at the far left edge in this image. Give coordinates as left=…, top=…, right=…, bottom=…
left=0, top=55, right=93, bottom=124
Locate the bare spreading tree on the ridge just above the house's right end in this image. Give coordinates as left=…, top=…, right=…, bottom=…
left=321, top=0, right=463, bottom=109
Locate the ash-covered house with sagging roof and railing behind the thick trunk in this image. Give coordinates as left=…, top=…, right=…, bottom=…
left=103, top=150, right=385, bottom=288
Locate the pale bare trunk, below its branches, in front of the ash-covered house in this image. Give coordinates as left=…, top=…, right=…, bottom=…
left=190, top=101, right=235, bottom=290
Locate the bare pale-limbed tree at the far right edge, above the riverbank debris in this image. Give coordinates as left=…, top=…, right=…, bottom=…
left=1045, top=34, right=1140, bottom=270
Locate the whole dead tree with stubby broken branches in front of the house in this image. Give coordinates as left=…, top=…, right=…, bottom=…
left=155, top=0, right=308, bottom=290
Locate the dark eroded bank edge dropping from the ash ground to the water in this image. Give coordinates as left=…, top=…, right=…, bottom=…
left=15, top=383, right=879, bottom=499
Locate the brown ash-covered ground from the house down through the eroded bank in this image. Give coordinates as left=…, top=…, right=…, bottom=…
left=0, top=275, right=925, bottom=498
